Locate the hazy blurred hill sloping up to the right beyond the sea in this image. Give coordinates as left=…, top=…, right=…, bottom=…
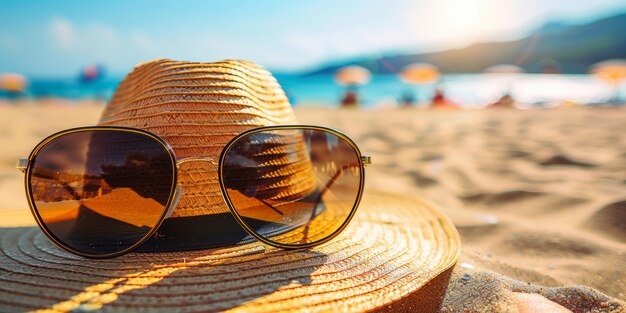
left=306, top=13, right=626, bottom=75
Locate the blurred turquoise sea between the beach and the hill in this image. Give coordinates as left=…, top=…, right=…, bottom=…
left=6, top=74, right=626, bottom=108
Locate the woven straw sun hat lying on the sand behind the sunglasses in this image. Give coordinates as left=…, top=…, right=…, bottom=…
left=0, top=60, right=460, bottom=312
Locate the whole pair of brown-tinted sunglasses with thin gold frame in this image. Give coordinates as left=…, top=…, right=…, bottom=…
left=17, top=125, right=370, bottom=258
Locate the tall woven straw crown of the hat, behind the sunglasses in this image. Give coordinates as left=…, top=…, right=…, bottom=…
left=100, top=60, right=314, bottom=217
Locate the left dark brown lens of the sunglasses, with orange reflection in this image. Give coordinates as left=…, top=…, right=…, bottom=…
left=28, top=129, right=175, bottom=256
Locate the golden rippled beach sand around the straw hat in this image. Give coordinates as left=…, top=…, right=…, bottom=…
left=0, top=101, right=626, bottom=312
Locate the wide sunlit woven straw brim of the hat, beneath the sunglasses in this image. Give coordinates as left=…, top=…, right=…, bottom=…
left=0, top=191, right=460, bottom=312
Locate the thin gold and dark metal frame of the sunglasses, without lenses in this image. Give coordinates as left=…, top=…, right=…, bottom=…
left=16, top=125, right=371, bottom=259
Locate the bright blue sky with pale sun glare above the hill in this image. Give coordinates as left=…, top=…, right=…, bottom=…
left=0, top=0, right=626, bottom=77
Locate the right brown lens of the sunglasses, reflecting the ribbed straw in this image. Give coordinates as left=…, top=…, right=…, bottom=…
left=221, top=128, right=363, bottom=247
